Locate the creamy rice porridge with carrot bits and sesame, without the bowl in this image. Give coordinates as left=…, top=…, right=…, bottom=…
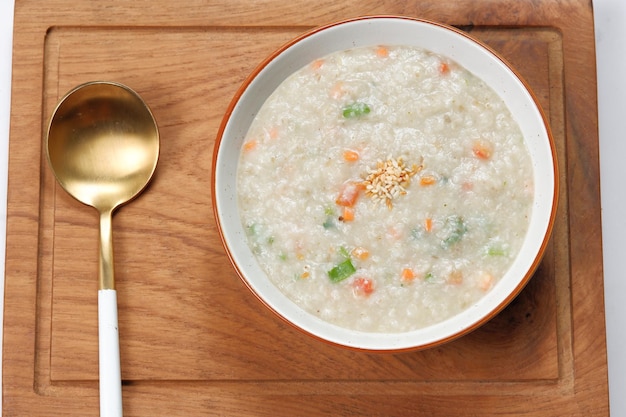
left=237, top=46, right=533, bottom=332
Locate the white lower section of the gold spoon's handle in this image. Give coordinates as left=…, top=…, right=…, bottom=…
left=98, top=289, right=122, bottom=417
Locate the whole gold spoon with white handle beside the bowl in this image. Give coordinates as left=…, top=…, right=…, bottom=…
left=47, top=82, right=159, bottom=417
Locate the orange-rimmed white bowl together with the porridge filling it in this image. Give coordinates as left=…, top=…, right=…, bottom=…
left=212, top=16, right=558, bottom=351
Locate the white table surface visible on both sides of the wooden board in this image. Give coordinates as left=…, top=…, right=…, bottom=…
left=0, top=0, right=626, bottom=416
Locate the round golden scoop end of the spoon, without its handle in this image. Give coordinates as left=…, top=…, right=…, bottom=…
left=48, top=82, right=159, bottom=210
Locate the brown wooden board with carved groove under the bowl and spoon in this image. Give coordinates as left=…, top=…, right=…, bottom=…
left=2, top=0, right=609, bottom=417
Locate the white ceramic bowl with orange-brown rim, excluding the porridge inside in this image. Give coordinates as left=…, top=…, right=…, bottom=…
left=212, top=16, right=558, bottom=351
